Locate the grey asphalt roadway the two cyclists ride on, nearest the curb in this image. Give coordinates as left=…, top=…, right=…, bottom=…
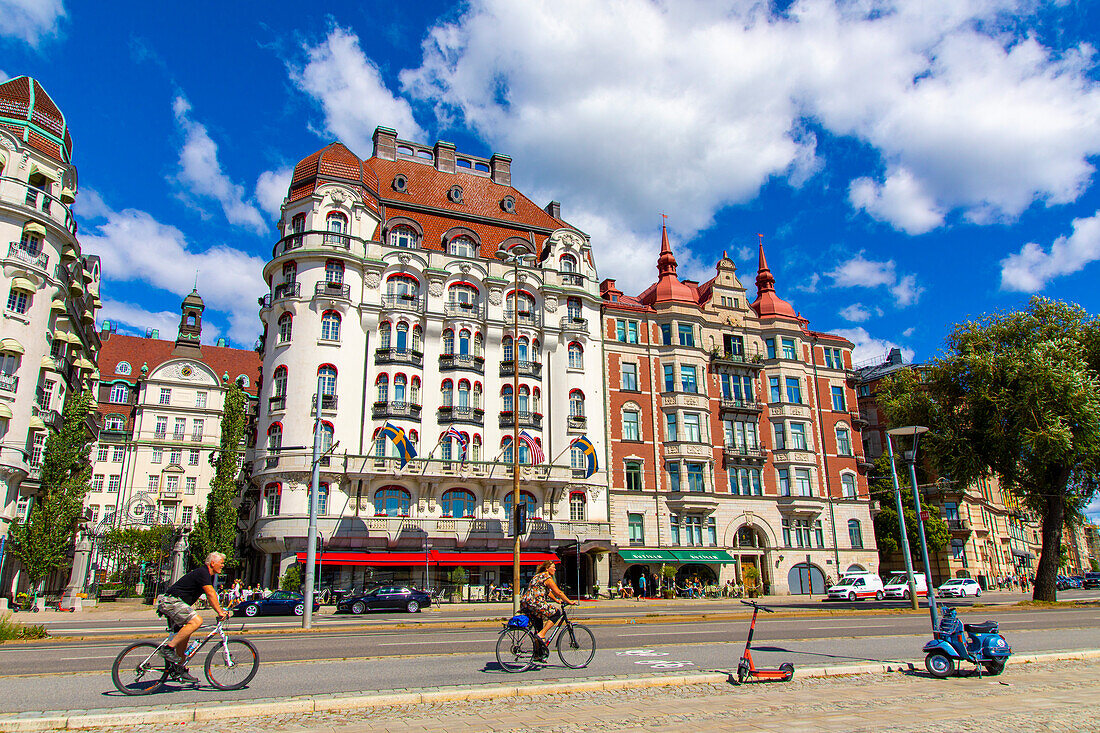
left=0, top=609, right=1100, bottom=712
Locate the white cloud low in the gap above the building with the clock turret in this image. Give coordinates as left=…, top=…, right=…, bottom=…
left=80, top=190, right=267, bottom=344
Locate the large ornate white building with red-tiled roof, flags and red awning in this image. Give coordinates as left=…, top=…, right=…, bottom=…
left=249, top=128, right=611, bottom=587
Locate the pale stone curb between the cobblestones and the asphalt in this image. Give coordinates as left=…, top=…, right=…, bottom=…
left=0, top=649, right=1100, bottom=733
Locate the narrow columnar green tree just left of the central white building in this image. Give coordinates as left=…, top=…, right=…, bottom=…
left=190, top=382, right=248, bottom=567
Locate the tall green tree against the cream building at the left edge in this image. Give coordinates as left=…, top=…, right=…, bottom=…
left=11, top=392, right=92, bottom=592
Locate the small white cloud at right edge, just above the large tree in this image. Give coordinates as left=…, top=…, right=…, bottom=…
left=1001, top=206, right=1100, bottom=293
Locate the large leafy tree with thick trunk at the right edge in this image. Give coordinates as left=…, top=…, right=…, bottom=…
left=880, top=297, right=1100, bottom=601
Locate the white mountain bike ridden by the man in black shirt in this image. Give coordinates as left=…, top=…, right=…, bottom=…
left=111, top=620, right=260, bottom=694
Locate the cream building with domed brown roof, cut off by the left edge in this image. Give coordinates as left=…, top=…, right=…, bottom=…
left=0, top=76, right=100, bottom=595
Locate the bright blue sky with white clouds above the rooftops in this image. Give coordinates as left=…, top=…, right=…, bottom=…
left=0, top=0, right=1100, bottom=512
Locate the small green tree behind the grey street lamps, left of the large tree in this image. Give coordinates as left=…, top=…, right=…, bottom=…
left=868, top=453, right=950, bottom=554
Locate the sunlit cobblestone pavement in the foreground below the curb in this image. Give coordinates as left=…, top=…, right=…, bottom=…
left=90, top=659, right=1100, bottom=733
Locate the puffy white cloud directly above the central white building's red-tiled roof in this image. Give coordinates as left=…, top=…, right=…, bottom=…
left=288, top=26, right=424, bottom=157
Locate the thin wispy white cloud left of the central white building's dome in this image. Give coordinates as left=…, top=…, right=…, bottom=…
left=172, top=97, right=268, bottom=234
